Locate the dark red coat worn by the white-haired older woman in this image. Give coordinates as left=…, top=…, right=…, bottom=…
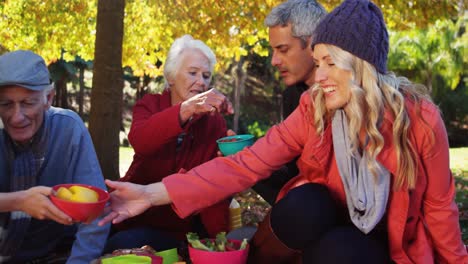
left=118, top=91, right=229, bottom=239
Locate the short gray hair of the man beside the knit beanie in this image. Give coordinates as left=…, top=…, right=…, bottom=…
left=265, top=0, right=327, bottom=46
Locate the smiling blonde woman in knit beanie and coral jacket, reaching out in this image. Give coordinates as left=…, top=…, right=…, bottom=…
left=101, top=0, right=468, bottom=264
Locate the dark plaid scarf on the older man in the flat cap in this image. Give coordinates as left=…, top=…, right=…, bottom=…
left=0, top=111, right=48, bottom=262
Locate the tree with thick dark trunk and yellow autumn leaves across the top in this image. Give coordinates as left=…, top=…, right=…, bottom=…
left=0, top=0, right=462, bottom=178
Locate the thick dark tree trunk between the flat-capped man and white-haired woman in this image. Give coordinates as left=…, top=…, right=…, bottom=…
left=89, top=0, right=125, bottom=180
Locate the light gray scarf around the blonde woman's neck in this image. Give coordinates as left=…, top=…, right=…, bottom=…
left=332, top=109, right=390, bottom=234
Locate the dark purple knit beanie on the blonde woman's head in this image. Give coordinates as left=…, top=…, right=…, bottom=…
left=312, top=0, right=388, bottom=74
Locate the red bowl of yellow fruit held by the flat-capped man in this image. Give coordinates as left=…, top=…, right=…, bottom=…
left=50, top=183, right=109, bottom=222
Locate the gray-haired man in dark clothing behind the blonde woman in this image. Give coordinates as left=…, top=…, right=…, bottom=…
left=253, top=0, right=327, bottom=204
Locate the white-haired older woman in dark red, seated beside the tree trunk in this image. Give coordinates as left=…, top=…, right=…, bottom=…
left=106, top=35, right=233, bottom=252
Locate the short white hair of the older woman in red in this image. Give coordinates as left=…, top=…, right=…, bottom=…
left=164, top=35, right=216, bottom=89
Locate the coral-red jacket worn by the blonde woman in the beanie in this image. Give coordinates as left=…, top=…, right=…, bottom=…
left=163, top=93, right=468, bottom=263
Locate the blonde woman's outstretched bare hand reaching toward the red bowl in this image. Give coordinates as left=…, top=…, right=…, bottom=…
left=99, top=180, right=171, bottom=226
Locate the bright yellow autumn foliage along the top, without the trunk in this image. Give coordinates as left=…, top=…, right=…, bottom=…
left=0, top=0, right=458, bottom=81
